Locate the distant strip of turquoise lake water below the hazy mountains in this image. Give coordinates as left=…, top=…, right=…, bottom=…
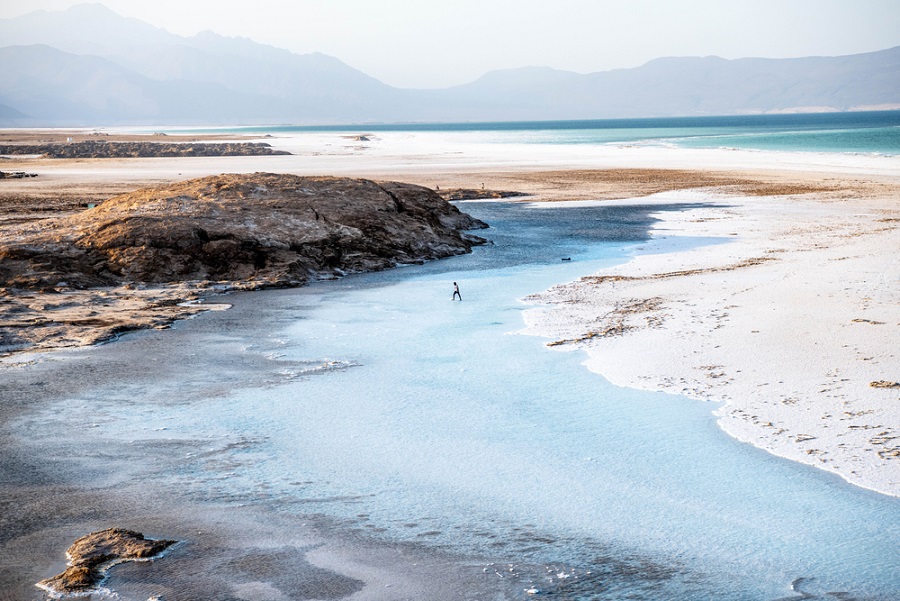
left=183, top=111, right=900, bottom=156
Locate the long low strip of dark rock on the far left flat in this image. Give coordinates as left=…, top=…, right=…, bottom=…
left=0, top=140, right=291, bottom=159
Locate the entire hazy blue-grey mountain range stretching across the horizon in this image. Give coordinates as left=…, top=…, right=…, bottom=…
left=0, top=4, right=900, bottom=127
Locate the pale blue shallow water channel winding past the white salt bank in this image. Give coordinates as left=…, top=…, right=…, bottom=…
left=60, top=203, right=900, bottom=600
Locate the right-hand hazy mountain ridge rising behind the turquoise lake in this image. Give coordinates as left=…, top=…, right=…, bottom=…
left=442, top=47, right=900, bottom=119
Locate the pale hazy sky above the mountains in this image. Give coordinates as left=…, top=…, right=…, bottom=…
left=0, top=0, right=900, bottom=88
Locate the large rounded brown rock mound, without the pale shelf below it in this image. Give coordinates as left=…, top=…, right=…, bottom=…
left=0, top=173, right=486, bottom=289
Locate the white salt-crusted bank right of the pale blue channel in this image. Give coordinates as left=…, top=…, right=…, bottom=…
left=525, top=191, right=900, bottom=496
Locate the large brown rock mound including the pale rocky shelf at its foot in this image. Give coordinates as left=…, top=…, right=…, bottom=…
left=0, top=173, right=486, bottom=353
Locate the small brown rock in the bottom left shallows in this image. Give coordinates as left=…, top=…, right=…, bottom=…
left=38, top=528, right=176, bottom=595
